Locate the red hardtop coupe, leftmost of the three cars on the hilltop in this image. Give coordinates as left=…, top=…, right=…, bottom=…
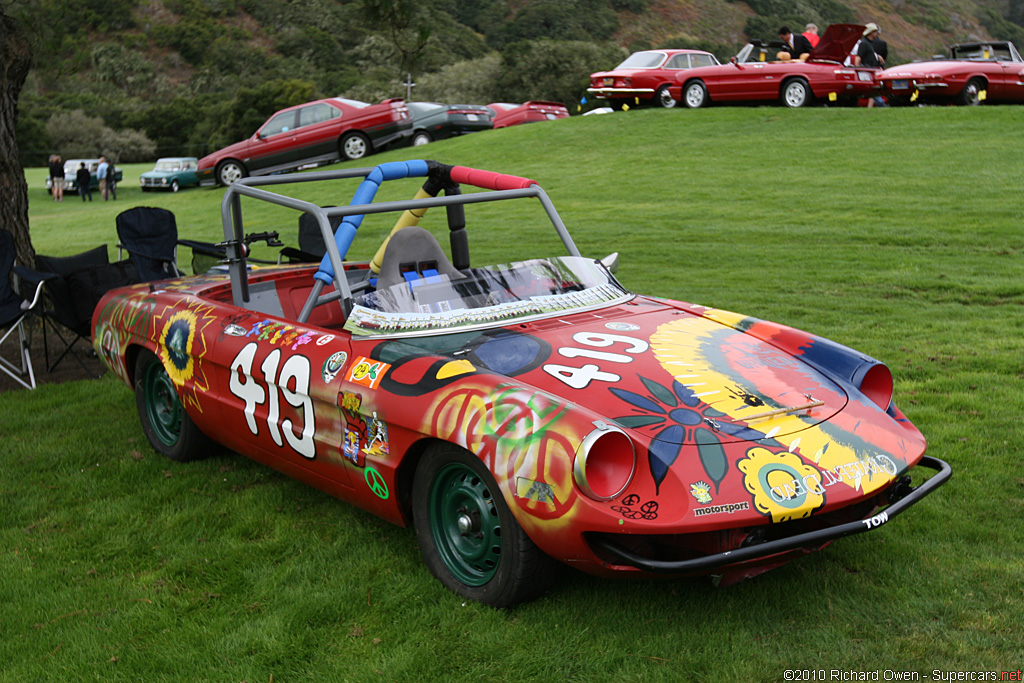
left=587, top=50, right=719, bottom=108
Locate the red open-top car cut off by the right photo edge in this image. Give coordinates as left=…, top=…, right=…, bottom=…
left=879, top=41, right=1024, bottom=104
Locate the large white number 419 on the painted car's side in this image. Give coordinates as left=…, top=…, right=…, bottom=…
left=229, top=342, right=316, bottom=459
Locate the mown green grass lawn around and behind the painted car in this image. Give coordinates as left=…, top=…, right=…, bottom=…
left=0, top=106, right=1024, bottom=683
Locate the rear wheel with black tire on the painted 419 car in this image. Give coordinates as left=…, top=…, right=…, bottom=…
left=134, top=349, right=218, bottom=463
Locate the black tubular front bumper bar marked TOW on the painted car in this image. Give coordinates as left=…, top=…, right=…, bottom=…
left=593, top=456, right=952, bottom=574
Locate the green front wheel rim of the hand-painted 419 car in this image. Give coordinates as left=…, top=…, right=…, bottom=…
left=429, top=463, right=502, bottom=586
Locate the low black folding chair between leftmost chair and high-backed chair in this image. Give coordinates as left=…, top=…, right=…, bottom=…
left=36, top=245, right=116, bottom=373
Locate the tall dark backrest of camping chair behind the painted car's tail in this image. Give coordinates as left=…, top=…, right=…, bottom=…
left=117, top=206, right=184, bottom=283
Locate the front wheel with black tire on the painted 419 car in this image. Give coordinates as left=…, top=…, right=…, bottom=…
left=413, top=443, right=558, bottom=607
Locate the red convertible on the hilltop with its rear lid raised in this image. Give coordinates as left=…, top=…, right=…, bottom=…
left=670, top=24, right=880, bottom=109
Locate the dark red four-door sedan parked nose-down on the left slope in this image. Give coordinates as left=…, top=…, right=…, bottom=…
left=198, top=97, right=413, bottom=185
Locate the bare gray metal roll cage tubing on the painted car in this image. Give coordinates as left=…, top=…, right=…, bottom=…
left=220, top=168, right=581, bottom=323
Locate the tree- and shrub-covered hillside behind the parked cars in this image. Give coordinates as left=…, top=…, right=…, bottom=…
left=12, top=0, right=1024, bottom=165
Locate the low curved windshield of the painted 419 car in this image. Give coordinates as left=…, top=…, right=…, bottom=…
left=345, top=256, right=632, bottom=336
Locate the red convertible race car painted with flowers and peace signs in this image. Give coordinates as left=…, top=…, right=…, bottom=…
left=93, top=161, right=950, bottom=606
